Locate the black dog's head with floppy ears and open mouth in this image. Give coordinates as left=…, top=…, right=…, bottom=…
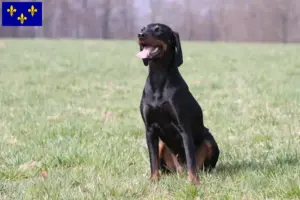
left=137, top=23, right=183, bottom=67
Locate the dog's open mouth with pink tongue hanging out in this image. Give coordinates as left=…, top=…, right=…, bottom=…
left=136, top=40, right=166, bottom=59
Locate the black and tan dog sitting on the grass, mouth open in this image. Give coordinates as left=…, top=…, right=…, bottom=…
left=137, top=23, right=219, bottom=184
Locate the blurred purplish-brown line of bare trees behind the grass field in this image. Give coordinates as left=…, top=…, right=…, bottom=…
left=0, top=0, right=300, bottom=43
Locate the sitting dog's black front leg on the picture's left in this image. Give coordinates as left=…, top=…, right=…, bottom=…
left=146, top=126, right=159, bottom=181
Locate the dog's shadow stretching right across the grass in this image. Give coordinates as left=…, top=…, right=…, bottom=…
left=214, top=156, right=300, bottom=175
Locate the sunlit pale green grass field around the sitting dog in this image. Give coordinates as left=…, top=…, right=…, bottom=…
left=0, top=40, right=300, bottom=200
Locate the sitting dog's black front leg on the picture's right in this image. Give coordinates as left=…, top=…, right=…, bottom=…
left=180, top=126, right=200, bottom=185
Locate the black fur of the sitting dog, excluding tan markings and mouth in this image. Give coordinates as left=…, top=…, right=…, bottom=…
left=139, top=23, right=219, bottom=182
